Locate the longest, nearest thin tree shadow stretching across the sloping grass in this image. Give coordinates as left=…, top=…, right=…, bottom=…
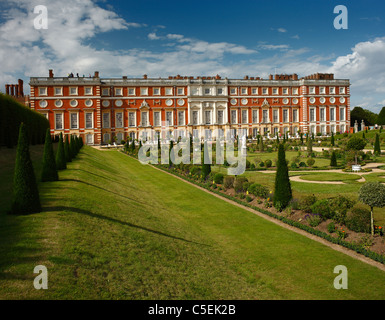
left=43, top=206, right=210, bottom=247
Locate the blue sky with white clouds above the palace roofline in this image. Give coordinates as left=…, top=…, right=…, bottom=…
left=0, top=0, right=385, bottom=112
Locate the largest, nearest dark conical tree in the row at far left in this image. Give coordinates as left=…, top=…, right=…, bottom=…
left=10, top=123, right=41, bottom=214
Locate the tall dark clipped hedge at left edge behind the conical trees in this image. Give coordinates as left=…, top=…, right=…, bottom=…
left=0, top=93, right=50, bottom=148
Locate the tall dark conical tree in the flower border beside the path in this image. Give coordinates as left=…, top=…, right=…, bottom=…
left=273, top=144, right=292, bottom=211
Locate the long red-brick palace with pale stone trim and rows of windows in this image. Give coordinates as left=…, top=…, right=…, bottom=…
left=29, top=70, right=350, bottom=145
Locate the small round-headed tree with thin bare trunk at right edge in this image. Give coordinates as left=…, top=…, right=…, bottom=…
left=358, top=182, right=385, bottom=235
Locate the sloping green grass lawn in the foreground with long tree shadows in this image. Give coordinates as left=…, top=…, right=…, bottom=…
left=0, top=147, right=385, bottom=299
